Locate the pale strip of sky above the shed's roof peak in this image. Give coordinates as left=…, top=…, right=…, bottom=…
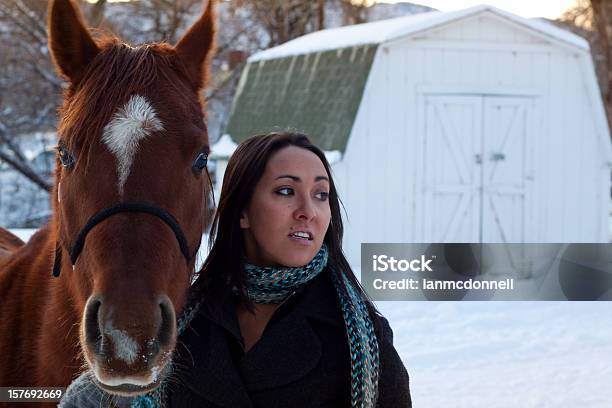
left=377, top=0, right=576, bottom=18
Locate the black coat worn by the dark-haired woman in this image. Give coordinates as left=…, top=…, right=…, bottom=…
left=168, top=271, right=412, bottom=408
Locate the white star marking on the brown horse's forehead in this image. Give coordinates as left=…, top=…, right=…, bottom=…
left=102, top=95, right=164, bottom=195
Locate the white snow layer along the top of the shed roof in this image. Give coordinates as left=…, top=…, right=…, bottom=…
left=248, top=5, right=589, bottom=62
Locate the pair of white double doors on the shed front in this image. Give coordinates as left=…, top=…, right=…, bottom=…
left=420, top=95, right=531, bottom=242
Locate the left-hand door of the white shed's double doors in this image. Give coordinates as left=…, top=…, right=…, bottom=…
left=420, top=96, right=482, bottom=242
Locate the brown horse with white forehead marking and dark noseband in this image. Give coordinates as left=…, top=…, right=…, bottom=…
left=0, top=0, right=215, bottom=406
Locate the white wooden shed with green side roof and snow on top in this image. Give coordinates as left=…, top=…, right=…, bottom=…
left=221, top=5, right=612, bottom=265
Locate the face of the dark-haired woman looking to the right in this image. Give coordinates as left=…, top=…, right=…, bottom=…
left=240, top=146, right=331, bottom=267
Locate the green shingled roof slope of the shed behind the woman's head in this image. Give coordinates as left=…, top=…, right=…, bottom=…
left=224, top=44, right=378, bottom=152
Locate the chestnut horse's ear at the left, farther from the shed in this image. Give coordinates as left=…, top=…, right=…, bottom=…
left=48, top=0, right=100, bottom=83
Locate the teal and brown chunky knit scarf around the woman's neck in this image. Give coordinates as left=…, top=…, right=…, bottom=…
left=131, top=244, right=379, bottom=408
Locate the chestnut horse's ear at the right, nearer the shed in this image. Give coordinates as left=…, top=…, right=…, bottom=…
left=175, top=0, right=215, bottom=89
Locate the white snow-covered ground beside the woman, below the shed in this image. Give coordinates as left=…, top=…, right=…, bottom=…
left=8, top=230, right=612, bottom=408
